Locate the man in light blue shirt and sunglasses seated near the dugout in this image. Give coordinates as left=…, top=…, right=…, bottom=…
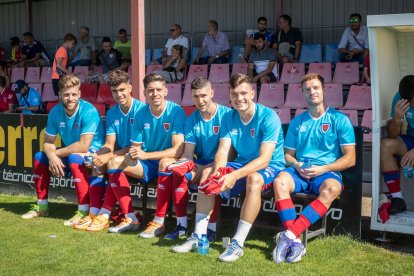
left=338, top=13, right=368, bottom=64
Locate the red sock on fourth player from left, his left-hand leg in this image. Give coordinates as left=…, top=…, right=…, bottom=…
left=173, top=174, right=190, bottom=217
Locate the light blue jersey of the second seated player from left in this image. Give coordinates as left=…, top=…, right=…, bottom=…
left=106, top=99, right=145, bottom=149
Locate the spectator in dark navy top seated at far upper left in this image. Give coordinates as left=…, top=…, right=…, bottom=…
left=19, top=32, right=50, bottom=67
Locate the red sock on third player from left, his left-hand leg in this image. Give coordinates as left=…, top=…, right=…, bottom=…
left=108, top=170, right=134, bottom=214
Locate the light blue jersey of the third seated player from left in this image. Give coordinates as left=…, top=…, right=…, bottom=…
left=131, top=101, right=186, bottom=152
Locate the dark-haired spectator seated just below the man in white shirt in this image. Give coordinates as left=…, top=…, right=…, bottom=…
left=154, top=44, right=187, bottom=83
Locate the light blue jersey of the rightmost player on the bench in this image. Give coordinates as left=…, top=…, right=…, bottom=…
left=285, top=107, right=355, bottom=166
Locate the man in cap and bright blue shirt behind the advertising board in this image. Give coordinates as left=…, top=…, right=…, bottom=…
left=14, top=80, right=42, bottom=114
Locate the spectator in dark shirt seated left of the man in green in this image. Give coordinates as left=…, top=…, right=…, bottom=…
left=87, top=37, right=128, bottom=83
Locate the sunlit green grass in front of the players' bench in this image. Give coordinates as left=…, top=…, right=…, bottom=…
left=0, top=195, right=414, bottom=275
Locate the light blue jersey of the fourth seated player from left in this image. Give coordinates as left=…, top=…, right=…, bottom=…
left=185, top=104, right=231, bottom=164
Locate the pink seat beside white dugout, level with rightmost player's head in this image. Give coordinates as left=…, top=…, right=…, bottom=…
left=343, top=85, right=372, bottom=110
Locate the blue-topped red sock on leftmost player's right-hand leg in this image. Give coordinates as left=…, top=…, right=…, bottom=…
left=68, top=154, right=89, bottom=205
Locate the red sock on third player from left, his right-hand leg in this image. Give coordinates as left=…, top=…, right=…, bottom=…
left=155, top=172, right=173, bottom=218
